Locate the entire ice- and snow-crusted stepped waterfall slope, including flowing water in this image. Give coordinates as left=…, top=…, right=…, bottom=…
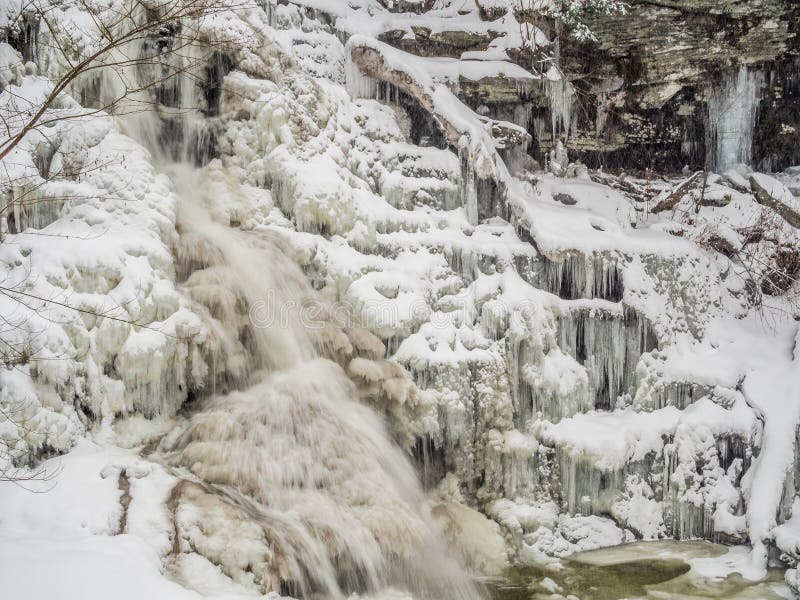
left=0, top=0, right=800, bottom=598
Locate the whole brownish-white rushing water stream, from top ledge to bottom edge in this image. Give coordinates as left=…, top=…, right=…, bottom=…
left=90, top=10, right=479, bottom=600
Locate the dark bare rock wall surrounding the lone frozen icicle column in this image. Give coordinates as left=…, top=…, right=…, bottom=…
left=562, top=0, right=800, bottom=169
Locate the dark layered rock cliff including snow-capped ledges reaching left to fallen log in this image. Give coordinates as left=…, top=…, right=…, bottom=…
left=368, top=0, right=800, bottom=170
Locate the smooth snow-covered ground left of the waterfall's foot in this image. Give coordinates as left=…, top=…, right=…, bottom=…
left=0, top=431, right=266, bottom=600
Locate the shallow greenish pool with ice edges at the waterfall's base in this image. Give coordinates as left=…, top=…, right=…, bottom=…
left=487, top=541, right=791, bottom=600
